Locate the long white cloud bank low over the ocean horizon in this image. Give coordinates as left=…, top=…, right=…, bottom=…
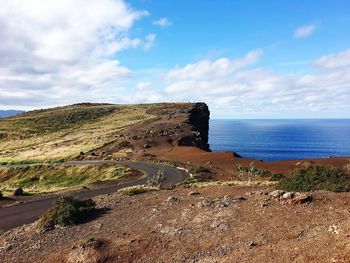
left=150, top=50, right=350, bottom=117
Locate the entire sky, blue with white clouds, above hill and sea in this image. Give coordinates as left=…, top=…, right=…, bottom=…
left=0, top=0, right=350, bottom=119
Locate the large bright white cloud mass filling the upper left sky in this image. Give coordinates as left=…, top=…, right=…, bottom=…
left=0, top=0, right=150, bottom=108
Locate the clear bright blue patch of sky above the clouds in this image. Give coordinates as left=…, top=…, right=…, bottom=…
left=118, top=0, right=350, bottom=71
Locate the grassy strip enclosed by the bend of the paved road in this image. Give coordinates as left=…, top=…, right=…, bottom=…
left=0, top=164, right=133, bottom=193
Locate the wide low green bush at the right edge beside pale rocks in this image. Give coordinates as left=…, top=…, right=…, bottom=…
left=278, top=166, right=350, bottom=192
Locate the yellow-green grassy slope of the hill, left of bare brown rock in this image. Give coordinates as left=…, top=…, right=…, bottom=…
left=0, top=104, right=157, bottom=162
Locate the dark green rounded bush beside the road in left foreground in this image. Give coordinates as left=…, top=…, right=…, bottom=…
left=38, top=197, right=95, bottom=230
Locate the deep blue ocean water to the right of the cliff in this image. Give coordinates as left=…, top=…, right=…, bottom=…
left=209, top=119, right=350, bottom=161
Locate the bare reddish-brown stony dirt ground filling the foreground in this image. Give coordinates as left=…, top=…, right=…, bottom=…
left=0, top=186, right=350, bottom=263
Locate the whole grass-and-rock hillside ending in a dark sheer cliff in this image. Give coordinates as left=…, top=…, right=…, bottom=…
left=0, top=103, right=209, bottom=162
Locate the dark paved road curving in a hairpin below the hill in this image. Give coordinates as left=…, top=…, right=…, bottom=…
left=0, top=161, right=188, bottom=231
